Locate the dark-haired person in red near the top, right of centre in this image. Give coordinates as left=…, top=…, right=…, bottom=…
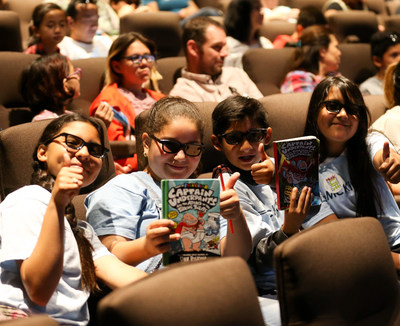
left=273, top=6, right=327, bottom=49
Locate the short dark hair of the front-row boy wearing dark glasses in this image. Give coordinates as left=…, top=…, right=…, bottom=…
left=212, top=95, right=269, bottom=136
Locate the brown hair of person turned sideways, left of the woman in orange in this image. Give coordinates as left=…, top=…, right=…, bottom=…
left=20, top=54, right=75, bottom=115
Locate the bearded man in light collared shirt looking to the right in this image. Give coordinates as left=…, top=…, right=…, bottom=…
left=170, top=17, right=263, bottom=102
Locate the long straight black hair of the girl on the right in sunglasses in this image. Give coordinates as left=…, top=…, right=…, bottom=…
left=304, top=76, right=382, bottom=217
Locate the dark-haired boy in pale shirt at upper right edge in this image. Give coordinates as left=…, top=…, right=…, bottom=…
left=360, top=31, right=400, bottom=95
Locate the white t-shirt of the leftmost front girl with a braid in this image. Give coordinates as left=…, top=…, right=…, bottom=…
left=0, top=185, right=111, bottom=325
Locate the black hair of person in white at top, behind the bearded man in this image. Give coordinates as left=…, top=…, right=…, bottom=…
left=224, top=0, right=260, bottom=43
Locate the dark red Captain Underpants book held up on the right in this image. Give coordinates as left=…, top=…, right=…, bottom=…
left=273, top=136, right=321, bottom=209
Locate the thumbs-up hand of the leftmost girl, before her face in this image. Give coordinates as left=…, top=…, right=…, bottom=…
left=52, top=152, right=83, bottom=207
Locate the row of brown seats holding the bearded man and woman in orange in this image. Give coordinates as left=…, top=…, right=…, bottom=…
left=0, top=44, right=375, bottom=129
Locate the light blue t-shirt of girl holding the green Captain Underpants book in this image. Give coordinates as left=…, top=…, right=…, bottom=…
left=85, top=171, right=227, bottom=272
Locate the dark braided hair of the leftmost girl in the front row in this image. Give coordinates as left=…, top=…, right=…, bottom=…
left=31, top=113, right=104, bottom=291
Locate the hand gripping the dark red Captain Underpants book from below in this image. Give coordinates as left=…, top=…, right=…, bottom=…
left=282, top=187, right=312, bottom=235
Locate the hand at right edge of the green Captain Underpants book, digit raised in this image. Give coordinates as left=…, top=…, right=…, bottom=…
left=220, top=172, right=241, bottom=220
